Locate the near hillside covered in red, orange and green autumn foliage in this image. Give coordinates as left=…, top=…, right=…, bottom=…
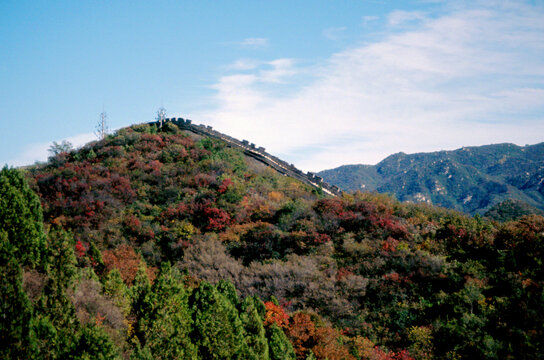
left=0, top=124, right=544, bottom=360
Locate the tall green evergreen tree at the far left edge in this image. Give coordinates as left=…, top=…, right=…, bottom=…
left=0, top=167, right=45, bottom=359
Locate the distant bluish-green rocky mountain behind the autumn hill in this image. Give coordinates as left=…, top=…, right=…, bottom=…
left=318, top=143, right=544, bottom=214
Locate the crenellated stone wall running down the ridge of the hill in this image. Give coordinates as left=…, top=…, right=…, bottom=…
left=149, top=118, right=342, bottom=196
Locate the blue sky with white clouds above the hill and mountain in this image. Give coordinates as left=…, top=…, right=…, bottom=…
left=0, top=0, right=544, bottom=171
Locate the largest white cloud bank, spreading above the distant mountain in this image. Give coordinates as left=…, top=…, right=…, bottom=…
left=198, top=2, right=544, bottom=170
